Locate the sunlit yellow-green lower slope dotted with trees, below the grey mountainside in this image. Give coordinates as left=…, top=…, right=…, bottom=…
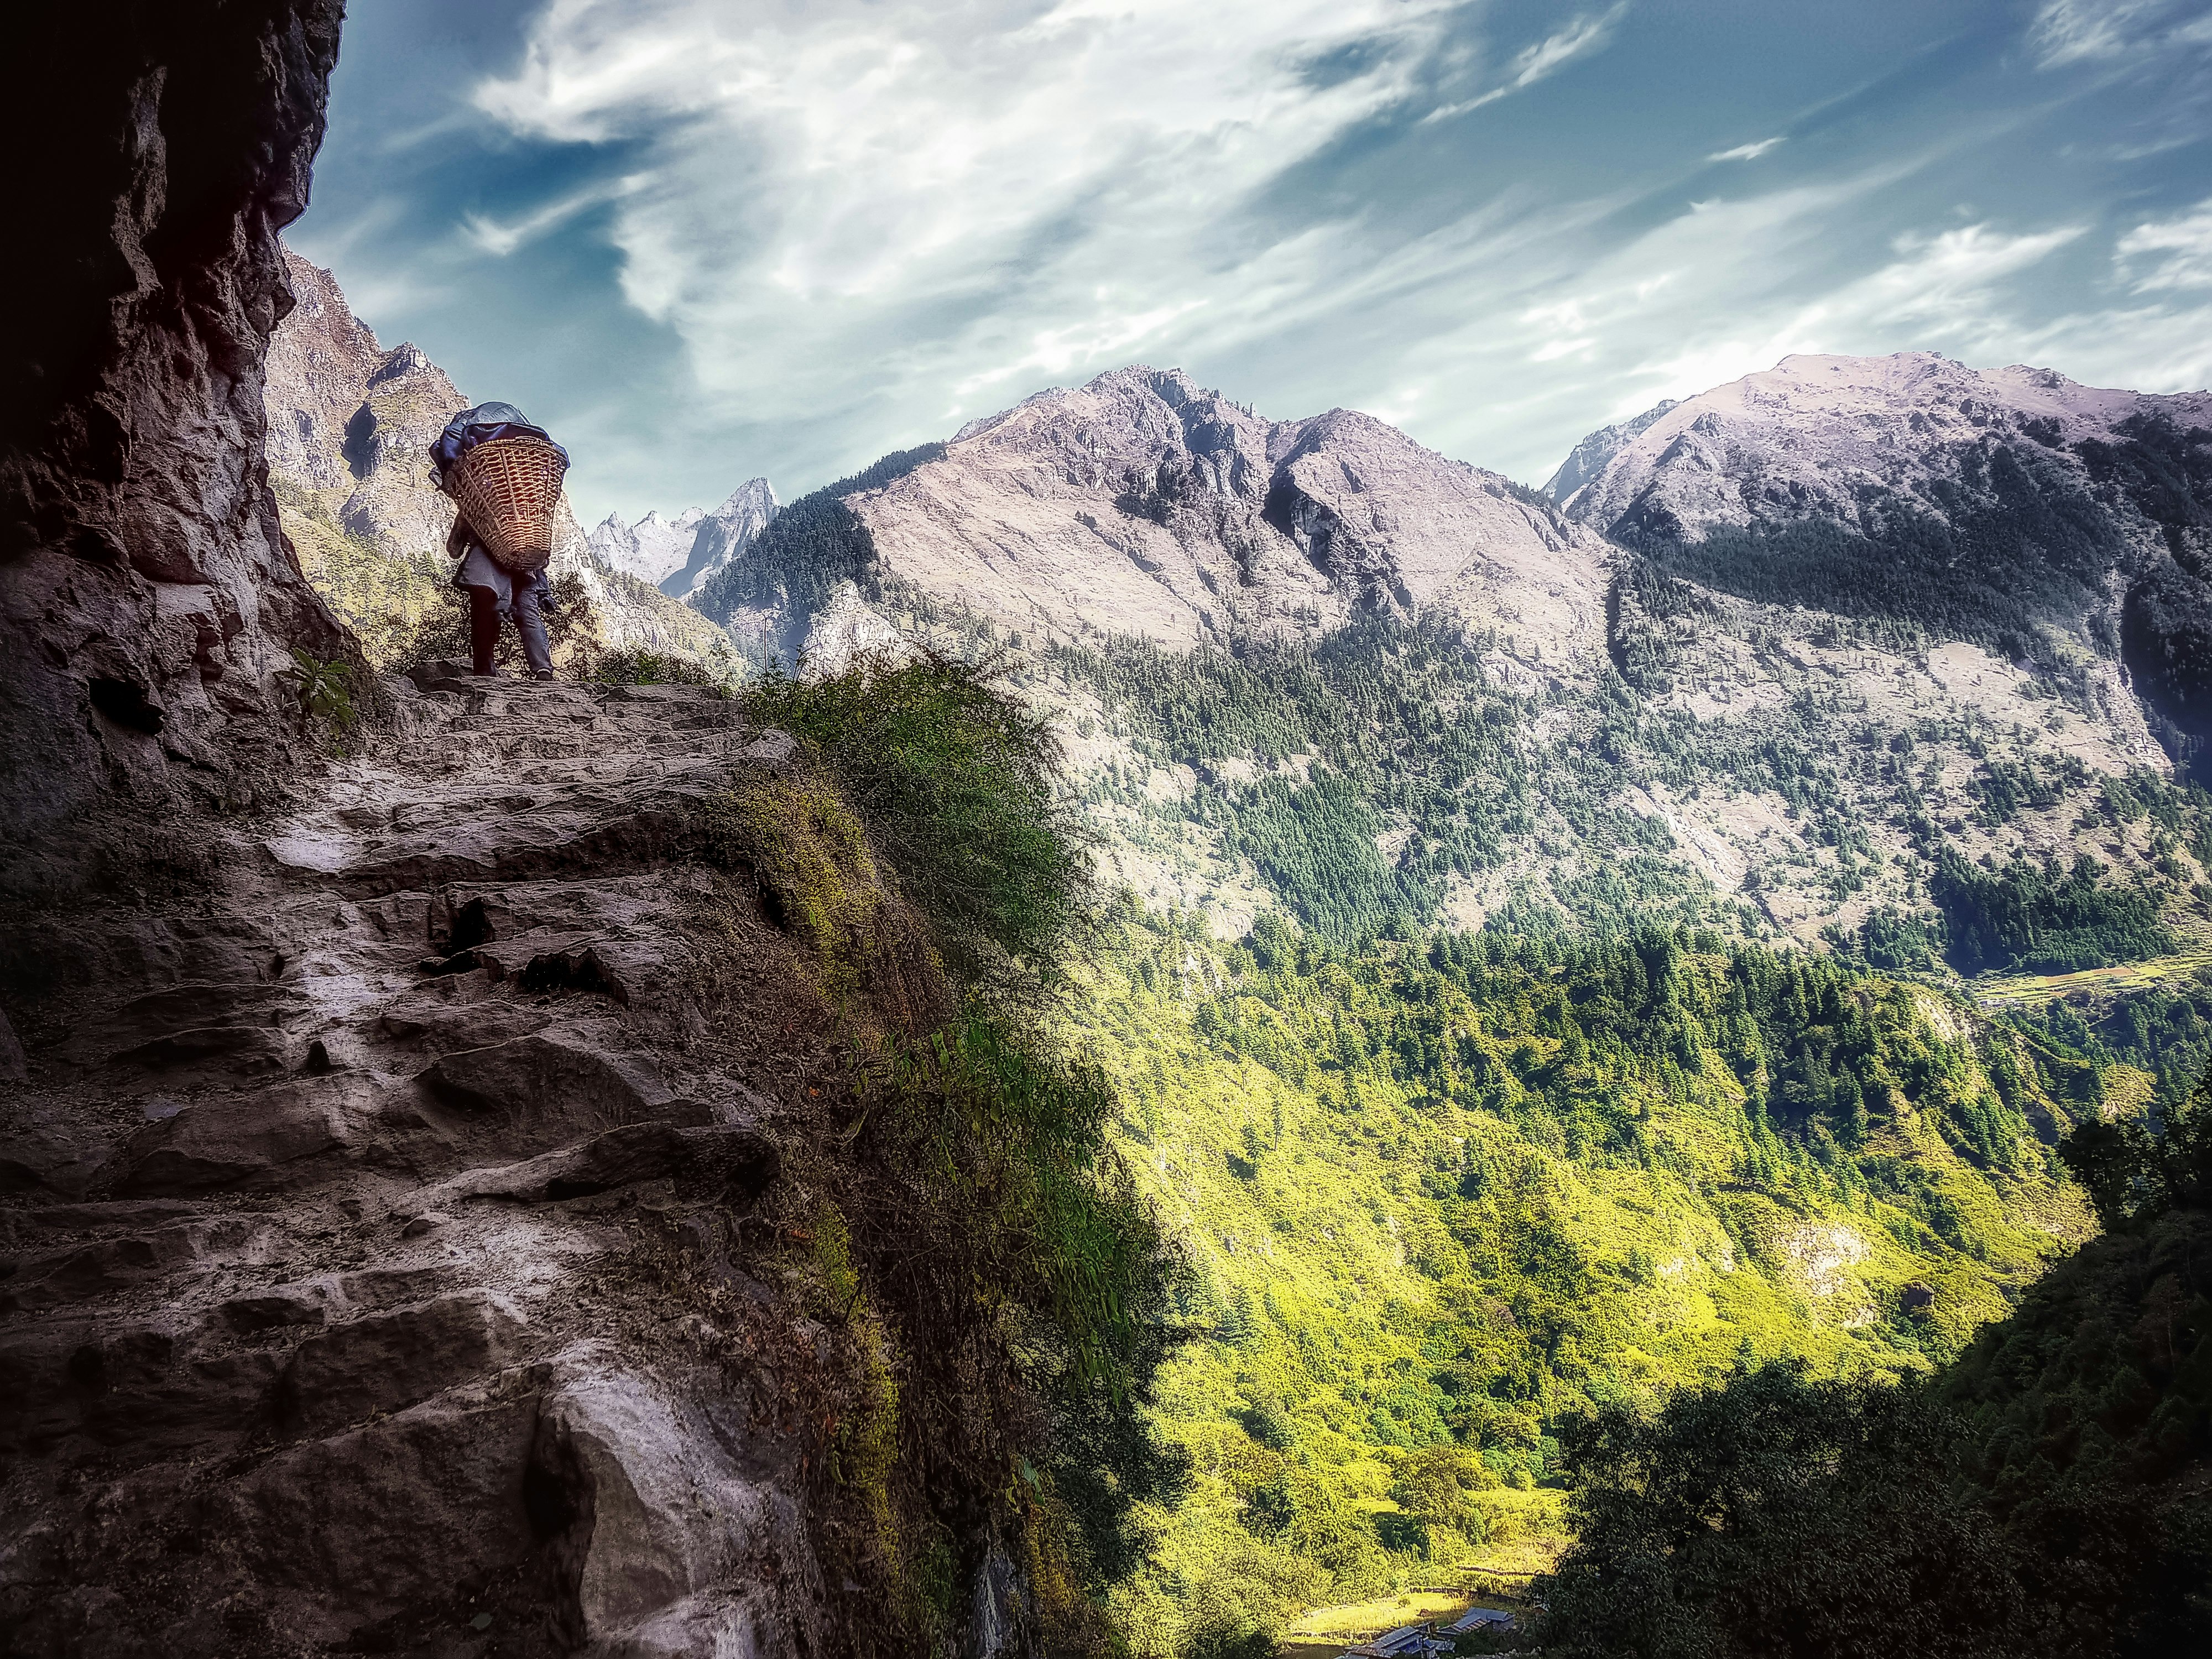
left=1062, top=916, right=2185, bottom=1652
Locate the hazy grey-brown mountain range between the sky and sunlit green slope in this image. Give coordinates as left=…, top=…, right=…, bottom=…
left=270, top=259, right=2212, bottom=967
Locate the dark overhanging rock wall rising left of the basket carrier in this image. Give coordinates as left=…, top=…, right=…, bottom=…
left=0, top=0, right=345, bottom=911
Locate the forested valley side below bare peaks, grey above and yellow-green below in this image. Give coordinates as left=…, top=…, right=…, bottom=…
left=668, top=361, right=2212, bottom=1655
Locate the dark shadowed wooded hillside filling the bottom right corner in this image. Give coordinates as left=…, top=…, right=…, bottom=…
left=1540, top=1082, right=2212, bottom=1659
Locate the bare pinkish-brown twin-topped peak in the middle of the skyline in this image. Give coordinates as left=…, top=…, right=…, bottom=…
left=847, top=367, right=1604, bottom=661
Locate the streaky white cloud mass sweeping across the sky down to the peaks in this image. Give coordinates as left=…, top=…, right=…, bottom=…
left=431, top=0, right=2212, bottom=507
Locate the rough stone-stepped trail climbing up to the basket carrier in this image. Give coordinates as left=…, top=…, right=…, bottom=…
left=0, top=677, right=845, bottom=1659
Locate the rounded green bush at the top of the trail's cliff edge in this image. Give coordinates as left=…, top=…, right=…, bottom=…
left=745, top=653, right=1097, bottom=980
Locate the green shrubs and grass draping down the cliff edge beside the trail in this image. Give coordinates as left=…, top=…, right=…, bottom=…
left=706, top=657, right=1186, bottom=1655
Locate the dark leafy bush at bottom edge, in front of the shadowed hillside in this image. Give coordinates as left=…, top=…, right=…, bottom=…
left=1540, top=1363, right=2026, bottom=1659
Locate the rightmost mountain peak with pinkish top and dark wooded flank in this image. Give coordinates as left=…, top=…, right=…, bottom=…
left=1555, top=352, right=2212, bottom=763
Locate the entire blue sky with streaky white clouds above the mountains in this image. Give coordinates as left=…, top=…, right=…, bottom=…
left=290, top=0, right=2212, bottom=518
